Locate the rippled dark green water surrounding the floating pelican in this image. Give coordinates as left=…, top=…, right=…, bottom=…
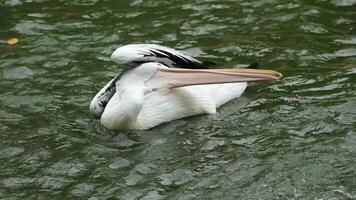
left=0, top=0, right=356, bottom=200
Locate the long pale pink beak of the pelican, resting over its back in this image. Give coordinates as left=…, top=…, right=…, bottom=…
left=146, top=67, right=282, bottom=89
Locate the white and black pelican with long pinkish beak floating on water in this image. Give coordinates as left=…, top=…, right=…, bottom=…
left=89, top=44, right=282, bottom=130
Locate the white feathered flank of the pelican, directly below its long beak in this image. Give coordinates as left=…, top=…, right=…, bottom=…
left=131, top=83, right=247, bottom=129
